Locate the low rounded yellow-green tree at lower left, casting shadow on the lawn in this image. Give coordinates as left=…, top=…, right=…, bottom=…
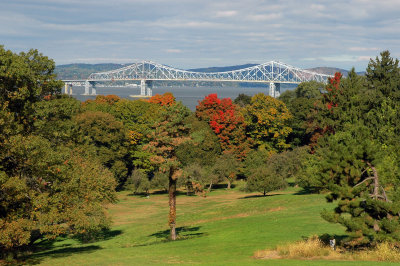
left=0, top=135, right=115, bottom=255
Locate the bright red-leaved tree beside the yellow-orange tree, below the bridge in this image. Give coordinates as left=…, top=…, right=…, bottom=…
left=196, top=94, right=250, bottom=159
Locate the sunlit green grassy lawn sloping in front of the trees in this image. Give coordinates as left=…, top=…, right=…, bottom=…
left=28, top=185, right=396, bottom=265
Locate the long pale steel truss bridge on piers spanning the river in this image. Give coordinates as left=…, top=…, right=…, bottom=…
left=64, top=61, right=332, bottom=97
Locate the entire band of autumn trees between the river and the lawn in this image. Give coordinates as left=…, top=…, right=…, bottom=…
left=0, top=47, right=400, bottom=256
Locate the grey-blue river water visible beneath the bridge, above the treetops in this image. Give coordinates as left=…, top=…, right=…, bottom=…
left=72, top=84, right=295, bottom=111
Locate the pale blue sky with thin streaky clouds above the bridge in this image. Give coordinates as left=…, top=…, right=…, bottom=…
left=0, top=0, right=400, bottom=71
